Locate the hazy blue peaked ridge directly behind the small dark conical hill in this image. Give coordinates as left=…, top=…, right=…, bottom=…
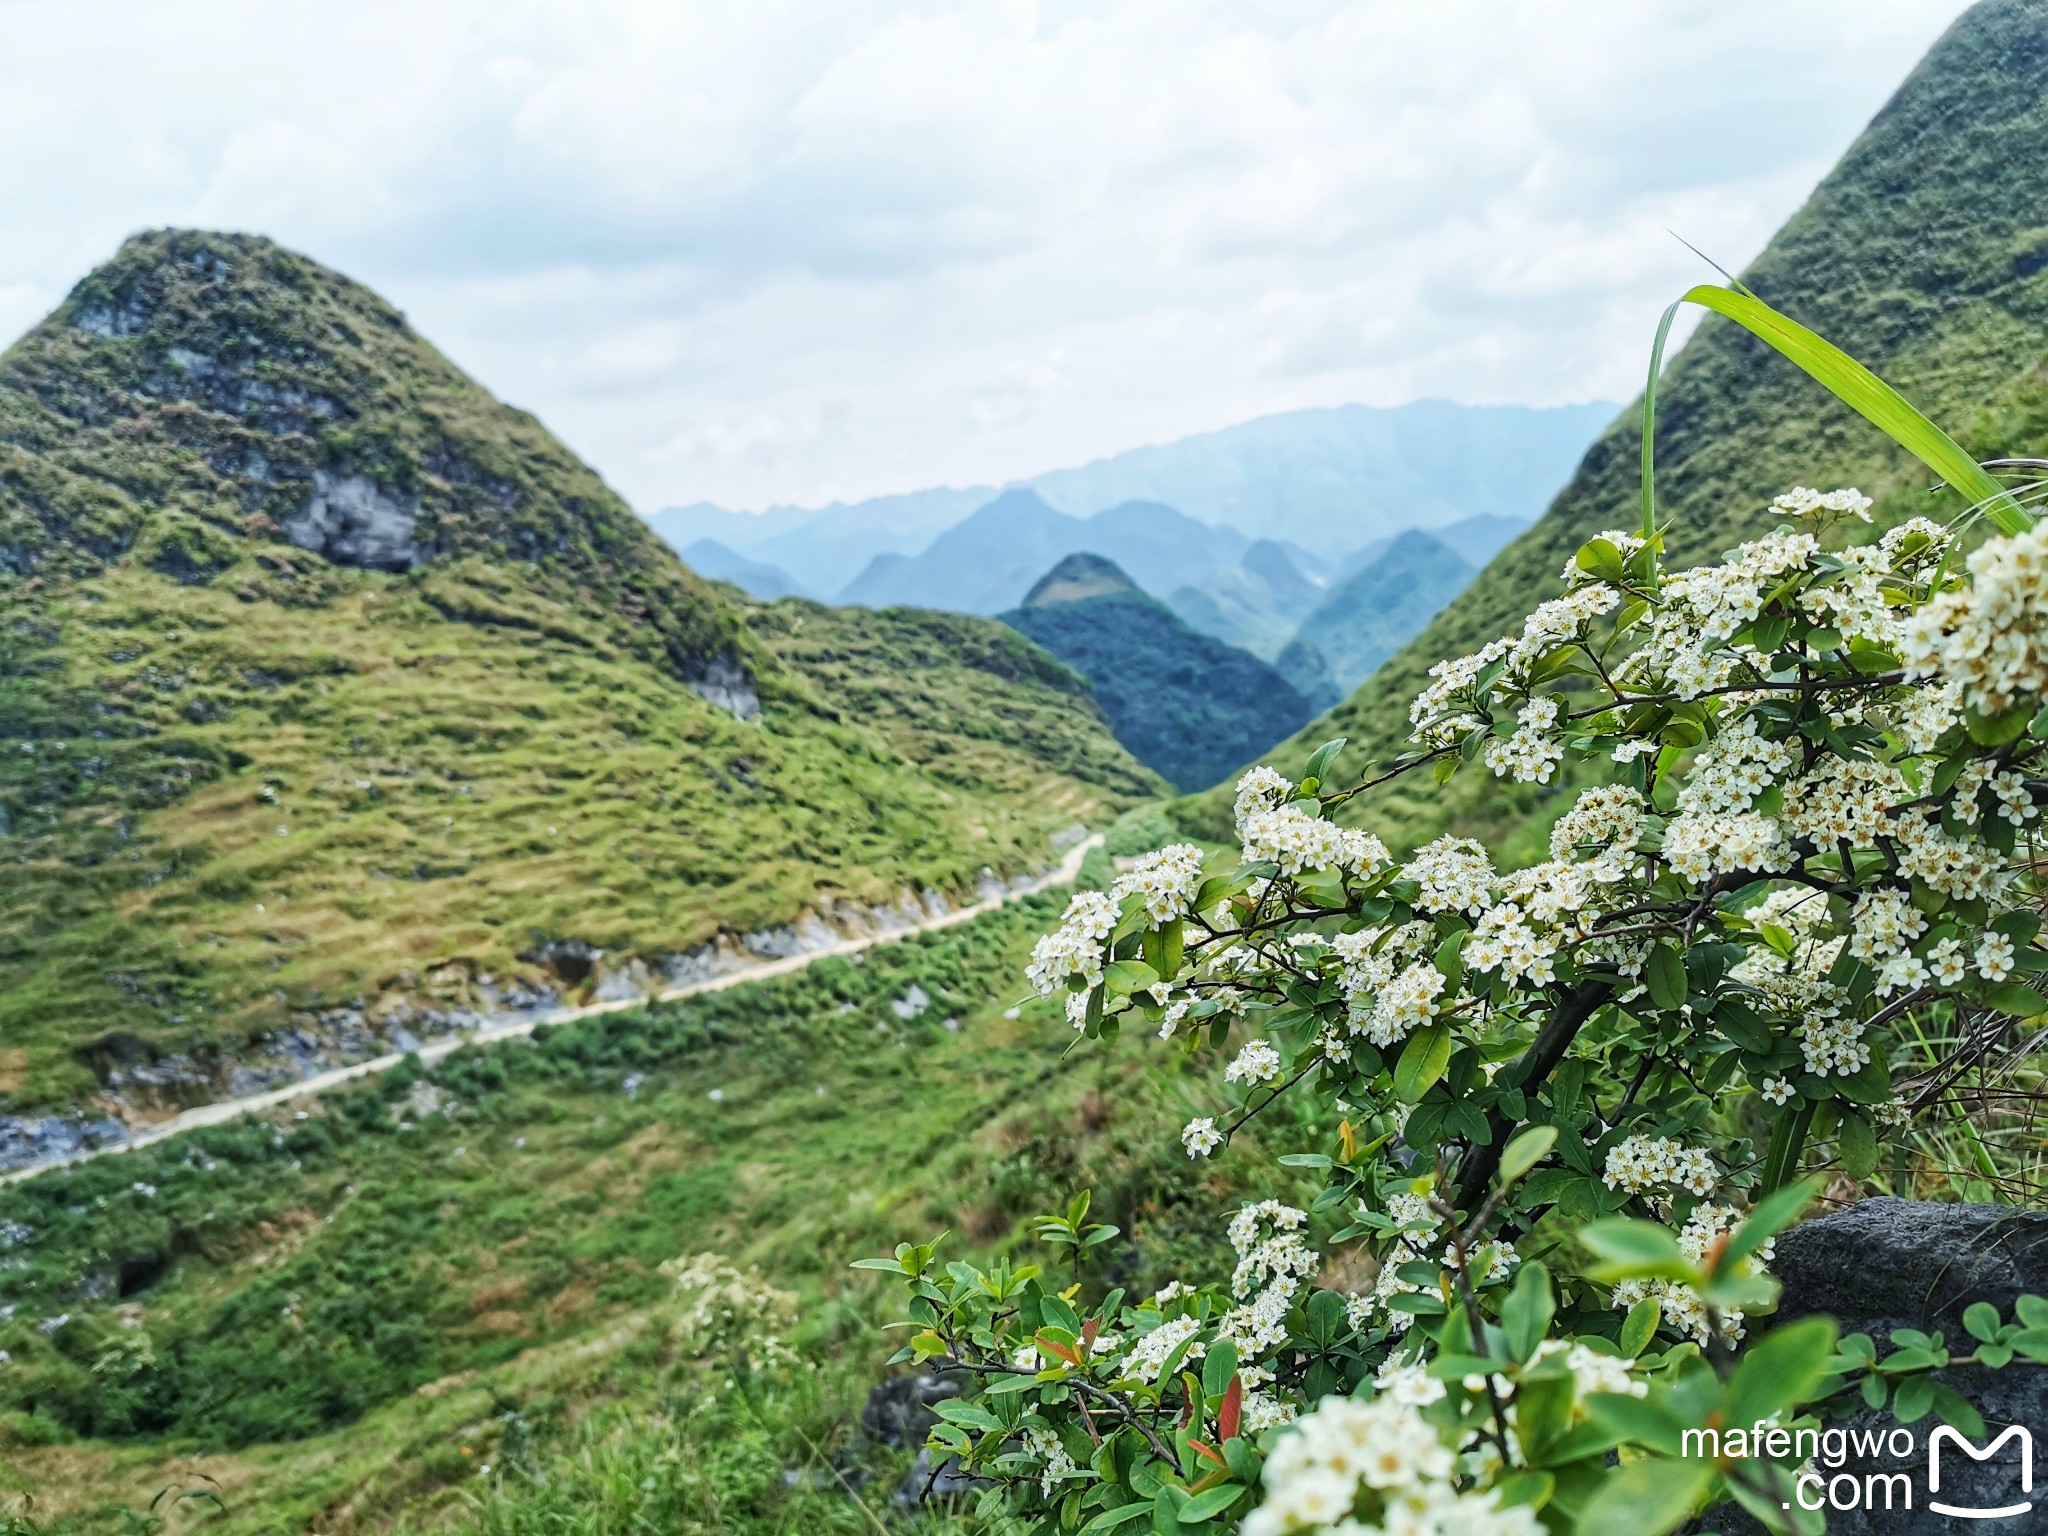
left=838, top=487, right=1249, bottom=612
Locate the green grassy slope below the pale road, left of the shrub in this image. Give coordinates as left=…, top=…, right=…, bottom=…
left=0, top=897, right=1288, bottom=1536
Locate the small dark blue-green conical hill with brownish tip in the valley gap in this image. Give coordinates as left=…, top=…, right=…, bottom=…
left=1004, top=553, right=1309, bottom=784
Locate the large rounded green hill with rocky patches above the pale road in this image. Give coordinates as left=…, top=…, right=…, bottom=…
left=0, top=231, right=1157, bottom=1108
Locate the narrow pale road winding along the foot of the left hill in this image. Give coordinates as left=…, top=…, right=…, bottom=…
left=0, top=831, right=1102, bottom=1184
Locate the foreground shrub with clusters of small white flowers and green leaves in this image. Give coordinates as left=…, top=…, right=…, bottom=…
left=870, top=290, right=2048, bottom=1536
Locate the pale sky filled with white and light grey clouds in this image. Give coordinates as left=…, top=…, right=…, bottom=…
left=0, top=0, right=1962, bottom=510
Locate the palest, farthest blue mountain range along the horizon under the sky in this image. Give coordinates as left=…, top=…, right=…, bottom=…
left=649, top=399, right=1616, bottom=612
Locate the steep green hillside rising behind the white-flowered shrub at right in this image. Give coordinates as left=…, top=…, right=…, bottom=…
left=1182, top=0, right=2048, bottom=838
